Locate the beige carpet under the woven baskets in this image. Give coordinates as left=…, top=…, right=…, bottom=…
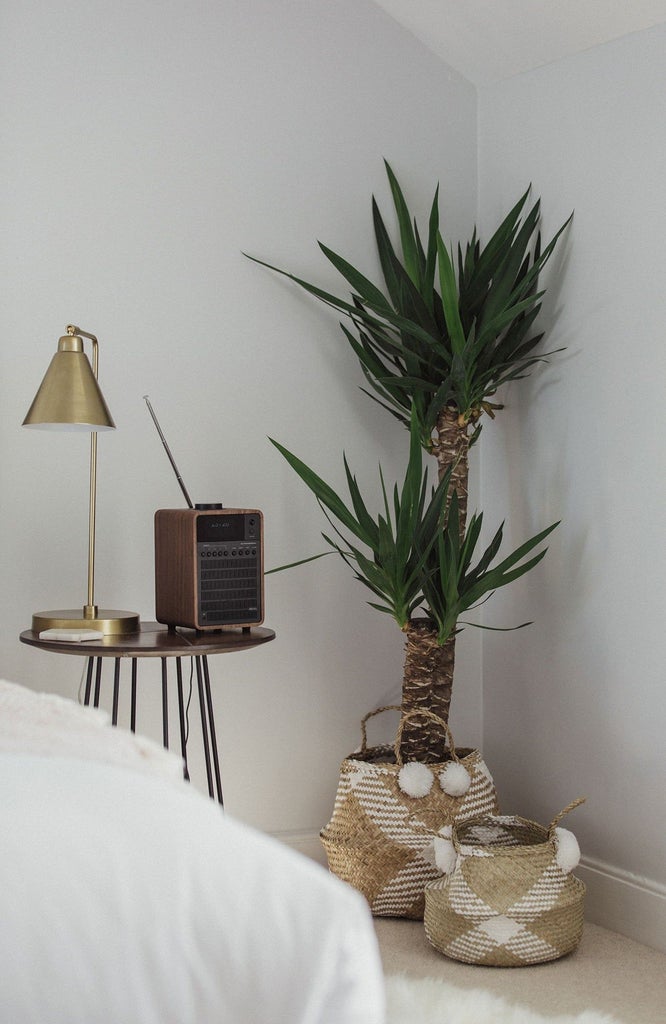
left=375, top=918, right=666, bottom=1024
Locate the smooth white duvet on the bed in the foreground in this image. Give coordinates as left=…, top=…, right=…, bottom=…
left=0, top=684, right=384, bottom=1024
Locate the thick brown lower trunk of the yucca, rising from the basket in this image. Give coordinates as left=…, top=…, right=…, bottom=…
left=401, top=618, right=456, bottom=762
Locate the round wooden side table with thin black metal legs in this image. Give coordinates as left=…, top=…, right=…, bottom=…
left=19, top=623, right=276, bottom=804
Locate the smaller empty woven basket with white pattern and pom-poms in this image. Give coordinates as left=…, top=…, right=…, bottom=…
left=424, top=800, right=585, bottom=967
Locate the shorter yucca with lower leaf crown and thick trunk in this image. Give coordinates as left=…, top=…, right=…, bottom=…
left=272, top=415, right=557, bottom=761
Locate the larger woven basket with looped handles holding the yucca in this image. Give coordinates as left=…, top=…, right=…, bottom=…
left=321, top=706, right=498, bottom=921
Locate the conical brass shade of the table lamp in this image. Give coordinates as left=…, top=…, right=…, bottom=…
left=24, top=334, right=116, bottom=430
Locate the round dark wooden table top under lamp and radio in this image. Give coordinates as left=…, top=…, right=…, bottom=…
left=18, top=623, right=276, bottom=657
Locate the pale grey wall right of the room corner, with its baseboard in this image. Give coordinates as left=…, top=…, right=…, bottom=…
left=478, top=27, right=666, bottom=948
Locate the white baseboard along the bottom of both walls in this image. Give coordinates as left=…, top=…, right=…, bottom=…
left=274, top=831, right=666, bottom=952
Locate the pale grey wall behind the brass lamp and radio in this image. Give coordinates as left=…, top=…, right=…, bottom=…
left=0, top=0, right=481, bottom=836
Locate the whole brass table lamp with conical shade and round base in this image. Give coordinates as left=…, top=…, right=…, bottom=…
left=24, top=326, right=139, bottom=634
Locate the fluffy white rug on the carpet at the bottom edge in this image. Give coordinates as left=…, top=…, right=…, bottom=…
left=386, top=975, right=618, bottom=1024
